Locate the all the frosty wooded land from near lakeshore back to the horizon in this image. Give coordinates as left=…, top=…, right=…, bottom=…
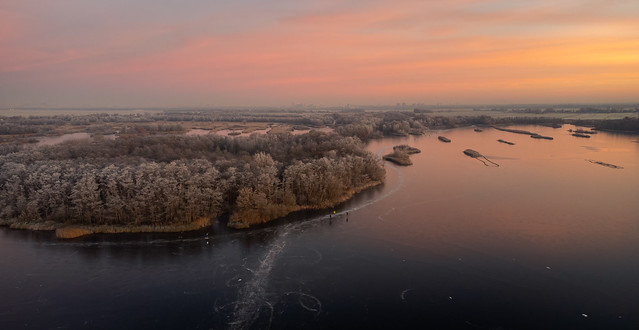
left=0, top=109, right=639, bottom=233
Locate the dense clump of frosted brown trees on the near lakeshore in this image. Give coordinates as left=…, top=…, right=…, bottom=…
left=0, top=131, right=385, bottom=225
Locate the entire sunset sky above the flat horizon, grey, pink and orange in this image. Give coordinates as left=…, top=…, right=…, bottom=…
left=0, top=0, right=639, bottom=107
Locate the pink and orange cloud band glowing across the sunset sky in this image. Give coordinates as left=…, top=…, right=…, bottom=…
left=0, top=1, right=639, bottom=104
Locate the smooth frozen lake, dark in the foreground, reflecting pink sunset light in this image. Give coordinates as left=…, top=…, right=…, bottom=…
left=0, top=126, right=639, bottom=329
